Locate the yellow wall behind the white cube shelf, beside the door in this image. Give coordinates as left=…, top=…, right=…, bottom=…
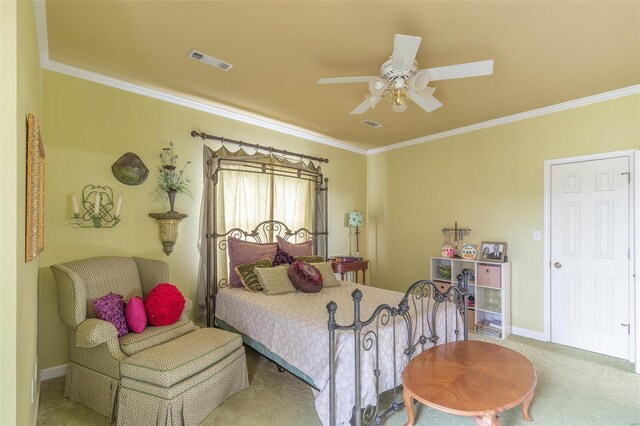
left=366, top=95, right=640, bottom=332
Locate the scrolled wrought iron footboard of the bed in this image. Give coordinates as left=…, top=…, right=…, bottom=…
left=327, top=271, right=468, bottom=426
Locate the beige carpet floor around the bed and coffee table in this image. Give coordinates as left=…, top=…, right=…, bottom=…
left=38, top=335, right=640, bottom=426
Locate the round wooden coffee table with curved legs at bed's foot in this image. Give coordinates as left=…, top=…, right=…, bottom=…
left=402, top=340, right=538, bottom=426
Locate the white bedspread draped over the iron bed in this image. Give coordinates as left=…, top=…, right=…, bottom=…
left=216, top=282, right=456, bottom=425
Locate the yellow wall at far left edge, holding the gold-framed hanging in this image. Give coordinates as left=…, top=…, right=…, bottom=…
left=0, top=1, right=41, bottom=425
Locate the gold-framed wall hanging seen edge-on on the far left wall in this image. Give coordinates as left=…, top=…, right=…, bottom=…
left=25, top=113, right=44, bottom=262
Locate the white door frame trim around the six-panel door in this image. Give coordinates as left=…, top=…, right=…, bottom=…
left=543, top=149, right=640, bottom=374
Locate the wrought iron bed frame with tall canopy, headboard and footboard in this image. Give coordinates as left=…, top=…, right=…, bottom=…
left=203, top=142, right=467, bottom=426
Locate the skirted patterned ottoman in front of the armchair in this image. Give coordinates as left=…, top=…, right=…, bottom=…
left=117, top=328, right=249, bottom=426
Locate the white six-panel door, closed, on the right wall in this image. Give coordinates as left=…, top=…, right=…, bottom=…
left=550, top=157, right=631, bottom=359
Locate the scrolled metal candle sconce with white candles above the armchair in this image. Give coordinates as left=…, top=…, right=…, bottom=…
left=71, top=185, right=122, bottom=228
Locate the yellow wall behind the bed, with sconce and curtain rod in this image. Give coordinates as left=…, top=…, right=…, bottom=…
left=40, top=71, right=367, bottom=368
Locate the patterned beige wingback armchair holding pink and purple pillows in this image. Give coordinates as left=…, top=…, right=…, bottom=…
left=51, top=257, right=197, bottom=420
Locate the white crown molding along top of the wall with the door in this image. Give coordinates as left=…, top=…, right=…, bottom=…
left=367, top=84, right=640, bottom=155
